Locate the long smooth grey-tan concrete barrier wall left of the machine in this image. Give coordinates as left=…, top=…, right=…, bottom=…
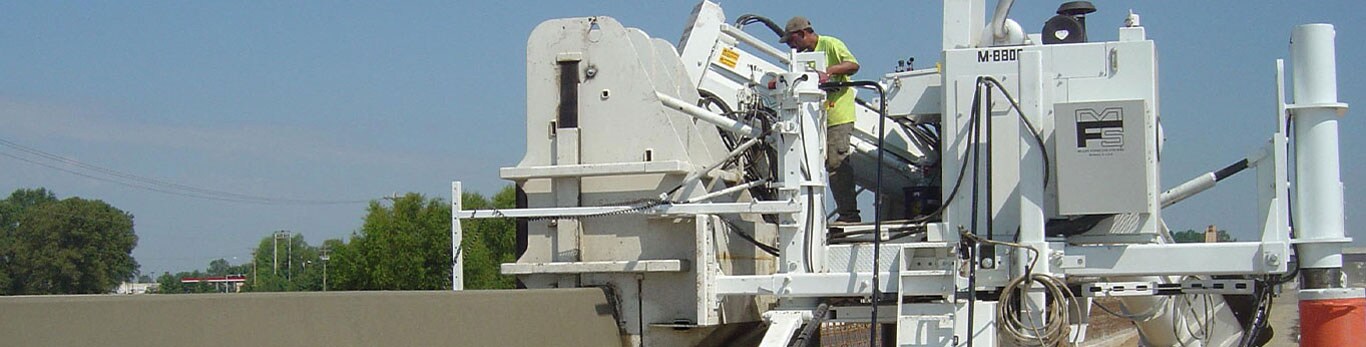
left=0, top=288, right=620, bottom=347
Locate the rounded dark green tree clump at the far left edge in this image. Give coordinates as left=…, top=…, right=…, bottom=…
left=8, top=191, right=138, bottom=294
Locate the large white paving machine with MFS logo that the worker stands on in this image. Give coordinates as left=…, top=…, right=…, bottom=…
left=452, top=0, right=1359, bottom=346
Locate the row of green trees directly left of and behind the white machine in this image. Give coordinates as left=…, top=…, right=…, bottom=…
left=157, top=186, right=516, bottom=294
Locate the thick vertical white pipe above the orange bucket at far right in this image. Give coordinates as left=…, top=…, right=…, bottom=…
left=1291, top=23, right=1346, bottom=268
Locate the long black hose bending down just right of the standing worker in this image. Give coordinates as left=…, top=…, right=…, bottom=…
left=821, top=81, right=887, bottom=346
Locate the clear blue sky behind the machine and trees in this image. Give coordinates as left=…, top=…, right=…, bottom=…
left=0, top=0, right=1366, bottom=275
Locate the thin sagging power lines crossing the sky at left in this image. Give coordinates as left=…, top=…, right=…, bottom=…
left=0, top=138, right=369, bottom=205
